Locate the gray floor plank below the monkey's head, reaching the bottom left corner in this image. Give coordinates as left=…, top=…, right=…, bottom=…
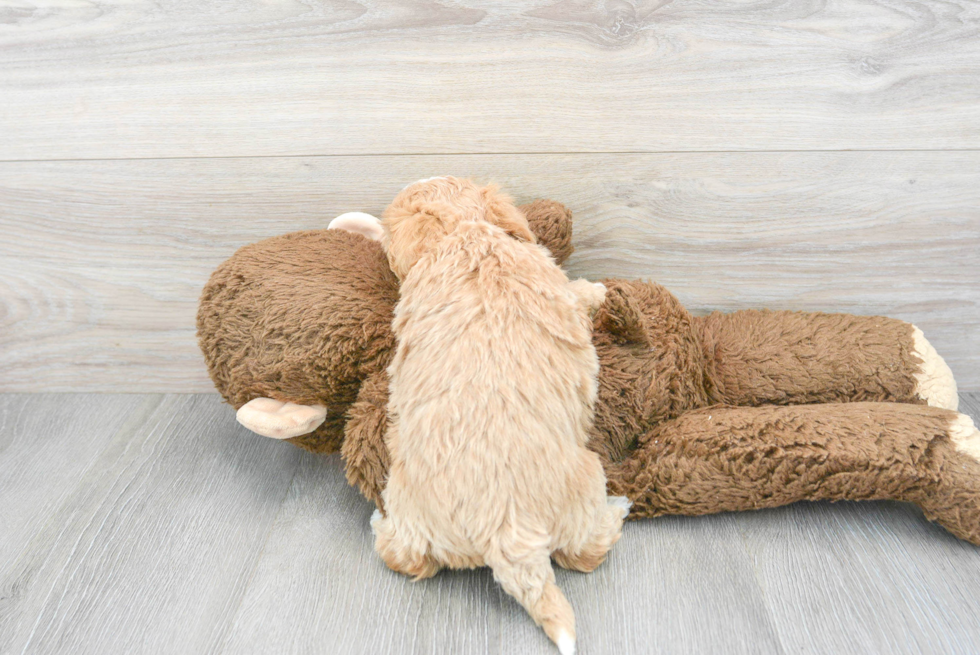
left=0, top=394, right=299, bottom=653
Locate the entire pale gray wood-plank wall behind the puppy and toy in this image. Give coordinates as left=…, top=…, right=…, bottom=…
left=0, top=0, right=980, bottom=392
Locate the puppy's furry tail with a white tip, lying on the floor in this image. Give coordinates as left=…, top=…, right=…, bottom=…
left=484, top=550, right=575, bottom=655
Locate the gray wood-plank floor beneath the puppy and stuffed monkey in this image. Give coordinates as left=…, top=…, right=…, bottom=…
left=0, top=394, right=980, bottom=655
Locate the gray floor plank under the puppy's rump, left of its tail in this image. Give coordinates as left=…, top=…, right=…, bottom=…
left=223, top=455, right=524, bottom=654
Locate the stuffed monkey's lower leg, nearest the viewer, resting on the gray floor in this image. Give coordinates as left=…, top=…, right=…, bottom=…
left=606, top=402, right=980, bottom=545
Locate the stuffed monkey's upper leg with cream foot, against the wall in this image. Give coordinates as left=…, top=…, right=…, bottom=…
left=694, top=310, right=958, bottom=409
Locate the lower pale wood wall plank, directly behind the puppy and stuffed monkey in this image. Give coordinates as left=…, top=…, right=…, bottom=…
left=0, top=152, right=980, bottom=392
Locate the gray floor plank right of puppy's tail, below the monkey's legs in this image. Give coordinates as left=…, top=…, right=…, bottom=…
left=556, top=515, right=785, bottom=655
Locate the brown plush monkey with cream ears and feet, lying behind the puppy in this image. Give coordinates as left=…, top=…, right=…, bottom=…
left=198, top=192, right=980, bottom=544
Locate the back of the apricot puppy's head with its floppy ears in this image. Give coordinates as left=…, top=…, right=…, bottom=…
left=381, top=177, right=535, bottom=279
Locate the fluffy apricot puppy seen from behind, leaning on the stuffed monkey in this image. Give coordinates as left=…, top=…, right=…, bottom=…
left=372, top=177, right=629, bottom=654
